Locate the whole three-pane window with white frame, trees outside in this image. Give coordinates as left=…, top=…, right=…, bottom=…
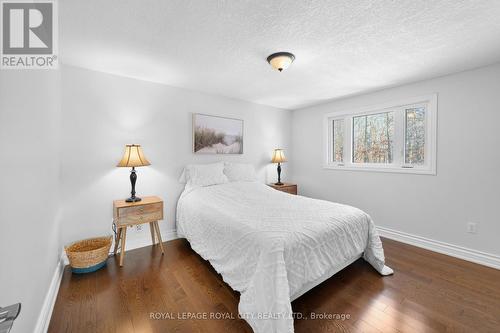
left=325, top=95, right=437, bottom=174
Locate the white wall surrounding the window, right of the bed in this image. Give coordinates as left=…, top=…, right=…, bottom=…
left=290, top=64, right=500, bottom=255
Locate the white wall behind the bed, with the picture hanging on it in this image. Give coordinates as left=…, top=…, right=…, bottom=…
left=62, top=66, right=291, bottom=247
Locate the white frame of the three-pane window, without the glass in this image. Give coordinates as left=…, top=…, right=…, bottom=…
left=323, top=94, right=437, bottom=175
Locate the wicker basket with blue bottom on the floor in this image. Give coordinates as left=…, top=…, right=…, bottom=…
left=64, top=236, right=112, bottom=273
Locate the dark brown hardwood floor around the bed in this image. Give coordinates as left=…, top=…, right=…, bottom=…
left=49, top=239, right=500, bottom=333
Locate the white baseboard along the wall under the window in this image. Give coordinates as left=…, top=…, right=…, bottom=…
left=377, top=227, right=500, bottom=269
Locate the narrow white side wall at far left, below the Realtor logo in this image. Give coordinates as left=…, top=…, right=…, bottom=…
left=0, top=70, right=61, bottom=333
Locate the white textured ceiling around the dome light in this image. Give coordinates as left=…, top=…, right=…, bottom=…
left=59, top=0, right=500, bottom=109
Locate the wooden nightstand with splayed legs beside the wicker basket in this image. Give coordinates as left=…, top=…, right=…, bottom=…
left=113, top=197, right=164, bottom=266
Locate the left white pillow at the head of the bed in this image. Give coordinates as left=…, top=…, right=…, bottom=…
left=179, top=162, right=228, bottom=187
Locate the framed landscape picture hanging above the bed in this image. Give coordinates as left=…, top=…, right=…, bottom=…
left=193, top=113, right=243, bottom=154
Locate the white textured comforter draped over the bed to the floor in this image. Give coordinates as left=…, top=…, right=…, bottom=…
left=177, top=182, right=392, bottom=333
